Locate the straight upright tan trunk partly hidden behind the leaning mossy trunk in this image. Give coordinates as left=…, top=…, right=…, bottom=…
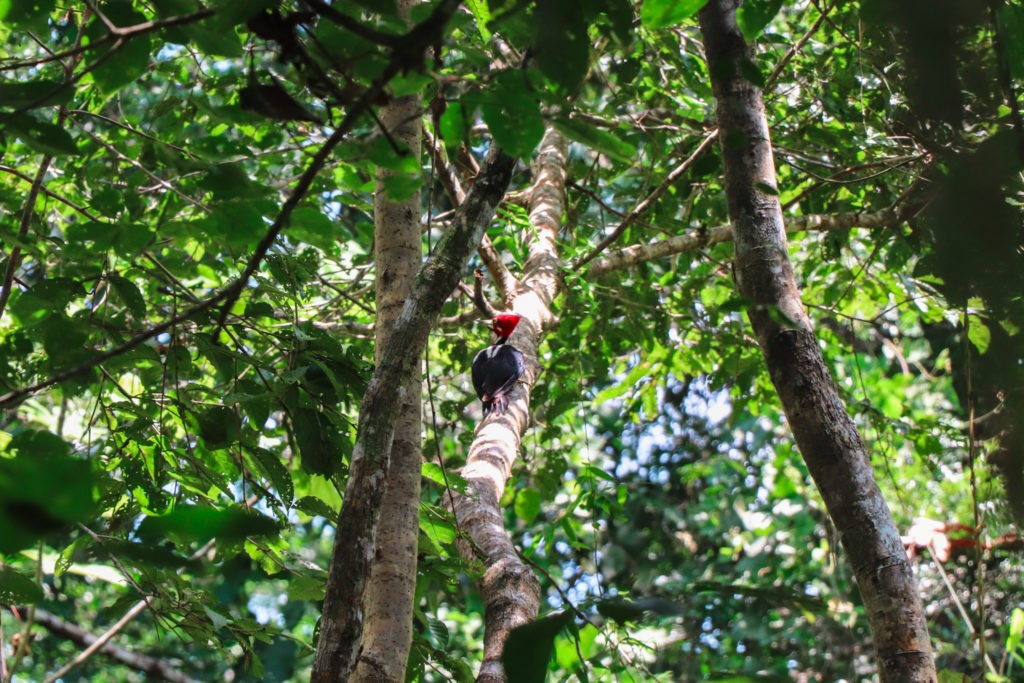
left=354, top=18, right=423, bottom=683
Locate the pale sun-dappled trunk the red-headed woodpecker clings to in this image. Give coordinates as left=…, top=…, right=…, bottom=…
left=454, top=128, right=566, bottom=683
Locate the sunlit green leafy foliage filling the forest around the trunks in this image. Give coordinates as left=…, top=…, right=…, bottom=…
left=0, top=0, right=1024, bottom=681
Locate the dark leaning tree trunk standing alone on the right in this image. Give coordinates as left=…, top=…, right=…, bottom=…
left=698, top=0, right=936, bottom=682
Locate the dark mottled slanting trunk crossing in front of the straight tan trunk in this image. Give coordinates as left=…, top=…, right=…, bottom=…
left=311, top=145, right=515, bottom=683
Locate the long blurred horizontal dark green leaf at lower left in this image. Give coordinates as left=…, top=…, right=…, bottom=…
left=138, top=505, right=281, bottom=543
